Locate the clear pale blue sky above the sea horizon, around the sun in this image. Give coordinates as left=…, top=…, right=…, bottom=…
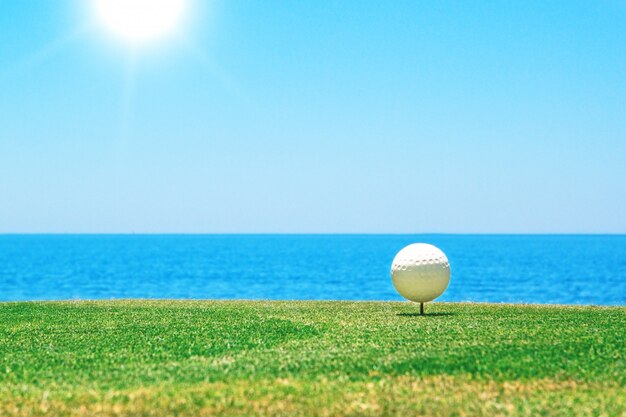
left=0, top=0, right=626, bottom=233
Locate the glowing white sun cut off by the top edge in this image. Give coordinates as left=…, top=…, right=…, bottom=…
left=93, top=0, right=188, bottom=45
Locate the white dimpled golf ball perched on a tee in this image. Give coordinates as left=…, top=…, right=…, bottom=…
left=391, top=243, right=450, bottom=303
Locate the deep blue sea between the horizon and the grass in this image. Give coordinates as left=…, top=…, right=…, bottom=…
left=0, top=235, right=626, bottom=305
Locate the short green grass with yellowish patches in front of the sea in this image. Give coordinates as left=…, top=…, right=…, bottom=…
left=0, top=301, right=626, bottom=416
